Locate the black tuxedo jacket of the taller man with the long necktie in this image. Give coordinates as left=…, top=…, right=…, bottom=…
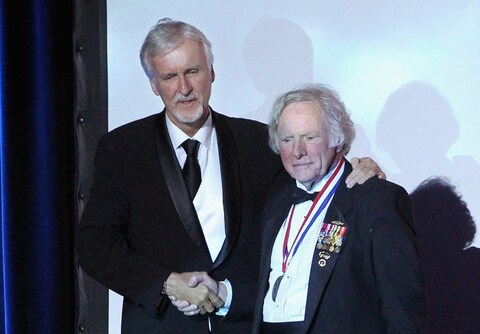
left=77, top=112, right=281, bottom=334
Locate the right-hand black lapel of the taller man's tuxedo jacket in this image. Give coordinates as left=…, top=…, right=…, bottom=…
left=212, top=111, right=242, bottom=268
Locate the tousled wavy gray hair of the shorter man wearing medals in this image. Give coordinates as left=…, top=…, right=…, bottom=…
left=268, top=84, right=355, bottom=155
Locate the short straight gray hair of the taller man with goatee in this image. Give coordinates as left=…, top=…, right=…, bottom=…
left=140, top=18, right=213, bottom=79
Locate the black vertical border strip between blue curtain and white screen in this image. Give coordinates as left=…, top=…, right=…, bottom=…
left=73, top=0, right=108, bottom=334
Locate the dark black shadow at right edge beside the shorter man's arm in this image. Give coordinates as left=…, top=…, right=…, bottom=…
left=411, top=178, right=480, bottom=334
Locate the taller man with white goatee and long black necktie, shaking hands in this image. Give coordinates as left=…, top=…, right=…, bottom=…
left=77, top=19, right=379, bottom=334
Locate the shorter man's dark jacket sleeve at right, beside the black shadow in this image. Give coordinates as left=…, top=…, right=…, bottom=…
left=372, top=188, right=425, bottom=333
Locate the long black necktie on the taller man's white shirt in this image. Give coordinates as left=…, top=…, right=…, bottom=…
left=182, top=139, right=202, bottom=199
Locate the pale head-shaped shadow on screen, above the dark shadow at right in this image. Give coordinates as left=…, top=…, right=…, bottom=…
left=376, top=81, right=480, bottom=219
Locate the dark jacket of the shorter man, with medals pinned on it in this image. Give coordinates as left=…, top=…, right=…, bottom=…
left=253, top=163, right=425, bottom=334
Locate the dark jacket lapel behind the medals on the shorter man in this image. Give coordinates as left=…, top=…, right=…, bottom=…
left=304, top=163, right=352, bottom=332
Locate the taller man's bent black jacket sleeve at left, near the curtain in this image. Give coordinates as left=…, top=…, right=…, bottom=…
left=76, top=137, right=172, bottom=315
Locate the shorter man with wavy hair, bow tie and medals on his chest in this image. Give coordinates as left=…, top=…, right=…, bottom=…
left=253, top=85, right=425, bottom=334
